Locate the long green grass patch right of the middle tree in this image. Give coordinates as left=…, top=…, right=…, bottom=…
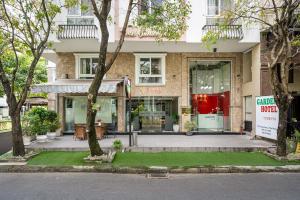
left=113, top=152, right=300, bottom=167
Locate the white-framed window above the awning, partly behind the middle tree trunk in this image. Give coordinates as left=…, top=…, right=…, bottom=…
left=75, top=54, right=99, bottom=79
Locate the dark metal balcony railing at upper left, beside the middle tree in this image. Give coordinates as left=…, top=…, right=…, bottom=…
left=57, top=25, right=98, bottom=39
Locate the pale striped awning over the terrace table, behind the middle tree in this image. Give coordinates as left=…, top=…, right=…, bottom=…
left=31, top=79, right=123, bottom=93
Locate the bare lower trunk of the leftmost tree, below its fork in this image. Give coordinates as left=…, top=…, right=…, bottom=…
left=10, top=112, right=25, bottom=156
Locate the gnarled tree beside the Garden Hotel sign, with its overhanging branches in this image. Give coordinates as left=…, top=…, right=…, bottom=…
left=204, top=0, right=300, bottom=156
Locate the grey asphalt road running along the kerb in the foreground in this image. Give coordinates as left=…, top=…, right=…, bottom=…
left=0, top=173, right=300, bottom=200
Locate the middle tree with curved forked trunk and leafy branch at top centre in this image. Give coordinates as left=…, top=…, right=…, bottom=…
left=87, top=0, right=190, bottom=156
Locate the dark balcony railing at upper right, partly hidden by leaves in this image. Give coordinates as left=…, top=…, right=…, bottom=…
left=202, top=25, right=243, bottom=39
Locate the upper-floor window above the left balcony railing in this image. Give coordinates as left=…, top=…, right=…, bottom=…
left=67, top=0, right=94, bottom=25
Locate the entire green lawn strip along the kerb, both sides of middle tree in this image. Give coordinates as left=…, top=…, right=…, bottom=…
left=28, top=151, right=300, bottom=167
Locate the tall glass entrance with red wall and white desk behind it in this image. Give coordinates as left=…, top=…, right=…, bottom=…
left=190, top=61, right=231, bottom=132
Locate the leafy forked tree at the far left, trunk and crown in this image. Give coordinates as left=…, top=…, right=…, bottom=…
left=0, top=0, right=60, bottom=156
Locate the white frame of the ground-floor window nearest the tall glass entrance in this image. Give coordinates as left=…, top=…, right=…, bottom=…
left=134, top=53, right=167, bottom=86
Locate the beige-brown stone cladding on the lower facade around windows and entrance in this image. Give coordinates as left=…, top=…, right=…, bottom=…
left=57, top=53, right=242, bottom=132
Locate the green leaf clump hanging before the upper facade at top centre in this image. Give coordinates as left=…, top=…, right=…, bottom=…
left=135, top=0, right=191, bottom=41
